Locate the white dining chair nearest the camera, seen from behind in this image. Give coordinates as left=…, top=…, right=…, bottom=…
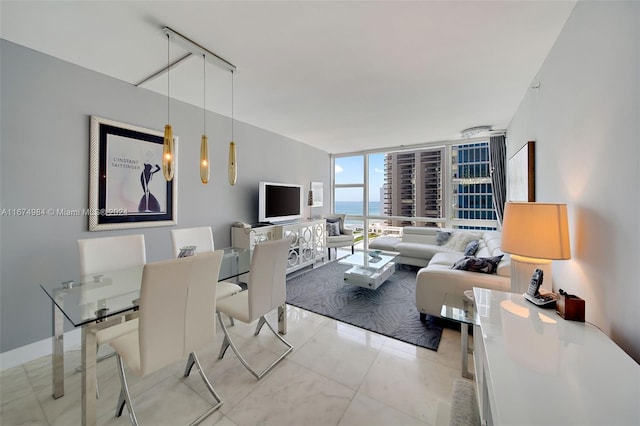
left=111, top=250, right=223, bottom=425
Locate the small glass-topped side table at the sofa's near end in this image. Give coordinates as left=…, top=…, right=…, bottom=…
left=440, top=293, right=479, bottom=380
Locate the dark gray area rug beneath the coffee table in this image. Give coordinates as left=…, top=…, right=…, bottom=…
left=287, top=261, right=442, bottom=351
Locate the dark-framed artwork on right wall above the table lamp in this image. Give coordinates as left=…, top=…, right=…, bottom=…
left=508, top=141, right=536, bottom=202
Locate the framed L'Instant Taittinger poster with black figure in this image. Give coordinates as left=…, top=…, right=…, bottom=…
left=89, top=116, right=178, bottom=231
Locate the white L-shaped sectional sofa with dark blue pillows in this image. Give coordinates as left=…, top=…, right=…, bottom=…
left=369, top=226, right=511, bottom=320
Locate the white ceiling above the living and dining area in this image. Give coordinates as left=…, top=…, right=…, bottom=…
left=0, top=0, right=575, bottom=154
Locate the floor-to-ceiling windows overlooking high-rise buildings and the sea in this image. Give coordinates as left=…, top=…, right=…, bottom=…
left=332, top=140, right=497, bottom=250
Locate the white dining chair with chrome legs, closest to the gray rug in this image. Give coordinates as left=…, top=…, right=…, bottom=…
left=217, top=238, right=293, bottom=380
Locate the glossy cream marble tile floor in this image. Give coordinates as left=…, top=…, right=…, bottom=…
left=0, top=306, right=470, bottom=426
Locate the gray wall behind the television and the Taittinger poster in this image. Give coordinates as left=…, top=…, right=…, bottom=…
left=0, top=40, right=330, bottom=352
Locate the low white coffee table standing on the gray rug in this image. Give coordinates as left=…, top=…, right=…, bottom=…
left=338, top=251, right=396, bottom=290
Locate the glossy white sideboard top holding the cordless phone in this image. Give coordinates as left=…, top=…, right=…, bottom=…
left=474, top=288, right=640, bottom=425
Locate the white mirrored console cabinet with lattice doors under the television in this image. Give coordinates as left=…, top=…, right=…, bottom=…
left=231, top=219, right=326, bottom=273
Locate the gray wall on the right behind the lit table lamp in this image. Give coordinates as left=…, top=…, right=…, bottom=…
left=507, top=1, right=640, bottom=362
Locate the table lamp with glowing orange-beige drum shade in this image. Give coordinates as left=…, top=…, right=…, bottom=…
left=500, top=202, right=571, bottom=293
